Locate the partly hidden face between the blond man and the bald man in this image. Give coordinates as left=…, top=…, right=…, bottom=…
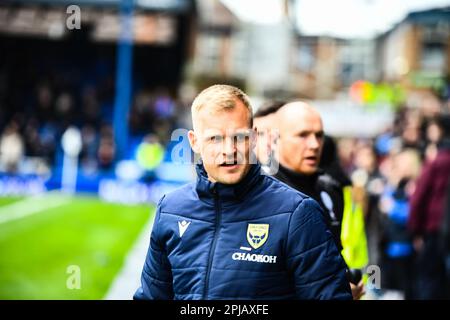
left=253, top=114, right=277, bottom=164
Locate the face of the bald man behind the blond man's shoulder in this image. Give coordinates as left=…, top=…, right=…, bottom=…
left=278, top=109, right=324, bottom=175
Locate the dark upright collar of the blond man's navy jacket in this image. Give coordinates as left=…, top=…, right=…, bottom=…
left=196, top=162, right=261, bottom=201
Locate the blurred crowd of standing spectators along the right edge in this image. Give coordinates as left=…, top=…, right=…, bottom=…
left=330, top=95, right=450, bottom=299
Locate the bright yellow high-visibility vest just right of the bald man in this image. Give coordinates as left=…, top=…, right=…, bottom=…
left=341, top=186, right=369, bottom=269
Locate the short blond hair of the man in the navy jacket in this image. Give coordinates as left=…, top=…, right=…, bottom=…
left=191, top=84, right=253, bottom=129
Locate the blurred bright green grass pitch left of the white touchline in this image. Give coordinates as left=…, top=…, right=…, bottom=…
left=0, top=195, right=154, bottom=299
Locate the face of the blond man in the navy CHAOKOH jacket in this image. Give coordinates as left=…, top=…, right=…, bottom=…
left=189, top=100, right=254, bottom=184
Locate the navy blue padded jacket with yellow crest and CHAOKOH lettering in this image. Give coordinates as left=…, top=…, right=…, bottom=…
left=134, top=165, right=352, bottom=300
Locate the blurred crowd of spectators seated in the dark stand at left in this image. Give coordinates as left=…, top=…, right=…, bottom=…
left=0, top=63, right=184, bottom=178
